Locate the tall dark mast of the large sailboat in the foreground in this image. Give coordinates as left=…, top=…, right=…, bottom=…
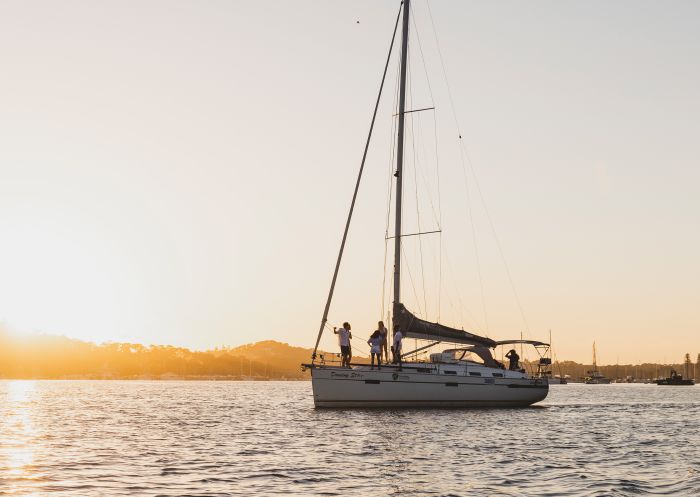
left=392, top=0, right=411, bottom=335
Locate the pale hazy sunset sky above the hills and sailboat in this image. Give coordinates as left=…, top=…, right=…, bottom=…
left=0, top=0, right=700, bottom=363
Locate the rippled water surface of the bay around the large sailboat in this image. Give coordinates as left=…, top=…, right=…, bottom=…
left=0, top=381, right=700, bottom=496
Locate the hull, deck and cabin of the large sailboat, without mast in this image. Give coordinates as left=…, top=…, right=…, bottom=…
left=305, top=337, right=549, bottom=407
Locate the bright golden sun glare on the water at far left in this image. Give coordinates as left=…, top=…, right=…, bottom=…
left=0, top=380, right=36, bottom=485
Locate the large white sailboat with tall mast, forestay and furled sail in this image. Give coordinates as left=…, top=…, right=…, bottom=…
left=302, top=0, right=551, bottom=407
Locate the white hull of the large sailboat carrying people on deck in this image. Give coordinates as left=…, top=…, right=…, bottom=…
left=311, top=364, right=549, bottom=407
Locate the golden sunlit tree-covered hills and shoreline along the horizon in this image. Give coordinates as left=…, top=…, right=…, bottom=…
left=0, top=329, right=700, bottom=380
